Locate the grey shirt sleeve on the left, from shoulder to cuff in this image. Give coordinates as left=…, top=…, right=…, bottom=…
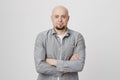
left=34, top=34, right=57, bottom=74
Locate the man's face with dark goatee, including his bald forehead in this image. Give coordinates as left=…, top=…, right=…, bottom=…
left=51, top=7, right=69, bottom=30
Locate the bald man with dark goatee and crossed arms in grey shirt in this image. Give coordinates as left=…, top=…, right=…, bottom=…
left=34, top=6, right=85, bottom=80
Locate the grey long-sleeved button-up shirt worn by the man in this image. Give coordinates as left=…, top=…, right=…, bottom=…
left=34, top=28, right=85, bottom=80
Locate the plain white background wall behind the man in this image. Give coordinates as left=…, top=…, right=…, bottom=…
left=0, top=0, right=120, bottom=80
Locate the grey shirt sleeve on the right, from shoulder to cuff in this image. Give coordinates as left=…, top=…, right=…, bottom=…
left=57, top=34, right=85, bottom=73
